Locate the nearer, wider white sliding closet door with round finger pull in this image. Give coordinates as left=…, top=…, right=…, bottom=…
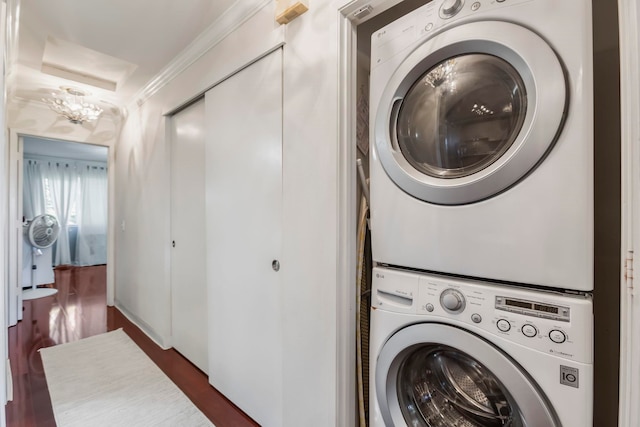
left=205, top=49, right=286, bottom=427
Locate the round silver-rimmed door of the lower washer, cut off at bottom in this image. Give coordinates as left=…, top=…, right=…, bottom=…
left=375, top=323, right=560, bottom=427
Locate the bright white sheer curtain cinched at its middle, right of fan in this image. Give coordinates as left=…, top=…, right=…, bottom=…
left=42, top=162, right=79, bottom=265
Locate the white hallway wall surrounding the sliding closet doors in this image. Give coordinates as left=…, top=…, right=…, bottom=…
left=116, top=1, right=344, bottom=426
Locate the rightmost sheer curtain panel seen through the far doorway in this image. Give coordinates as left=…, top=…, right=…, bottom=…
left=75, top=166, right=107, bottom=266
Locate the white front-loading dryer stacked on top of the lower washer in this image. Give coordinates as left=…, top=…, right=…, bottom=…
left=370, top=0, right=593, bottom=291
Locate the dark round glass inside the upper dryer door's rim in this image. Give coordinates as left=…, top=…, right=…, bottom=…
left=398, top=53, right=527, bottom=178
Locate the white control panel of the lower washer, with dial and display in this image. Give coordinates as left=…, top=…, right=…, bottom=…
left=371, top=267, right=593, bottom=363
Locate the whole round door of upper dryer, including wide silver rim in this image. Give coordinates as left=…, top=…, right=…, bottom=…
left=374, top=22, right=567, bottom=205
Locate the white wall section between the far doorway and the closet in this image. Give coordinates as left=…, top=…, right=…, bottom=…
left=115, top=102, right=171, bottom=348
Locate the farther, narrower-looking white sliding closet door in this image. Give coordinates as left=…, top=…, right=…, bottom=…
left=171, top=99, right=208, bottom=372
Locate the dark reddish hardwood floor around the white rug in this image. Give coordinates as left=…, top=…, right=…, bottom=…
left=6, top=266, right=258, bottom=427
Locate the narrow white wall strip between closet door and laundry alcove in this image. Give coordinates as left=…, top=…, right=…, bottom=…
left=281, top=1, right=340, bottom=426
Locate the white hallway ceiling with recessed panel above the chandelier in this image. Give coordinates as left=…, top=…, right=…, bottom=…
left=8, top=0, right=242, bottom=117
